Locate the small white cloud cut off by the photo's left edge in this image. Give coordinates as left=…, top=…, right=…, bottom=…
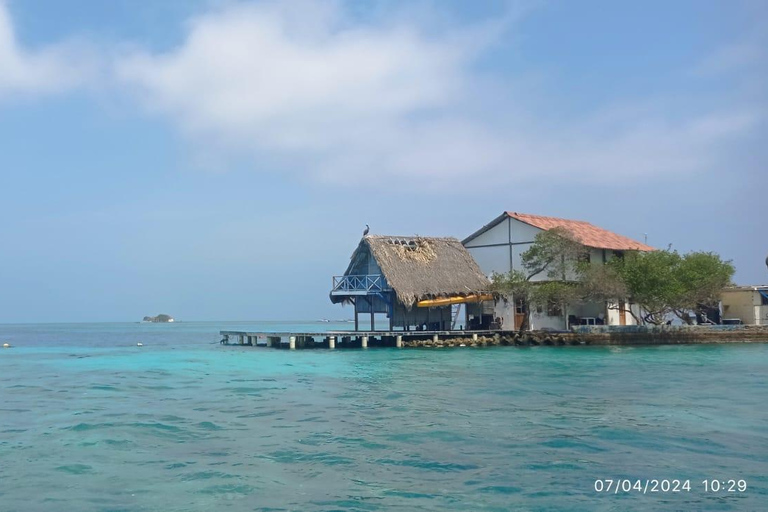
left=0, top=0, right=94, bottom=101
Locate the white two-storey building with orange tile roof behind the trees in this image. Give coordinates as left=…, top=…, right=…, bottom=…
left=462, top=212, right=654, bottom=329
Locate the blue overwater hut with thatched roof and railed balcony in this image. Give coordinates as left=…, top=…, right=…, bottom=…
left=330, top=235, right=493, bottom=331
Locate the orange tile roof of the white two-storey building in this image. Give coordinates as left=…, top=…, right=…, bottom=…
left=507, top=212, right=656, bottom=251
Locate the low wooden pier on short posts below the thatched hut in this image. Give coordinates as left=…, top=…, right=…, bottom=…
left=219, top=330, right=511, bottom=350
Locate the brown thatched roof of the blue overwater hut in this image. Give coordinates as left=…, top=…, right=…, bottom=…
left=338, top=235, right=491, bottom=308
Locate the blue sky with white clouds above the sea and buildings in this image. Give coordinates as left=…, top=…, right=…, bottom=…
left=0, top=0, right=768, bottom=323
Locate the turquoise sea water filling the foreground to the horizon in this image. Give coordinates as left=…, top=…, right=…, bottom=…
left=0, top=323, right=768, bottom=512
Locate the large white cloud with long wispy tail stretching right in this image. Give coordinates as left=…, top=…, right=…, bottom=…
left=117, top=2, right=756, bottom=185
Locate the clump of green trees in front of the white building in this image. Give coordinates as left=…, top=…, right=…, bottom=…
left=492, top=228, right=735, bottom=330
